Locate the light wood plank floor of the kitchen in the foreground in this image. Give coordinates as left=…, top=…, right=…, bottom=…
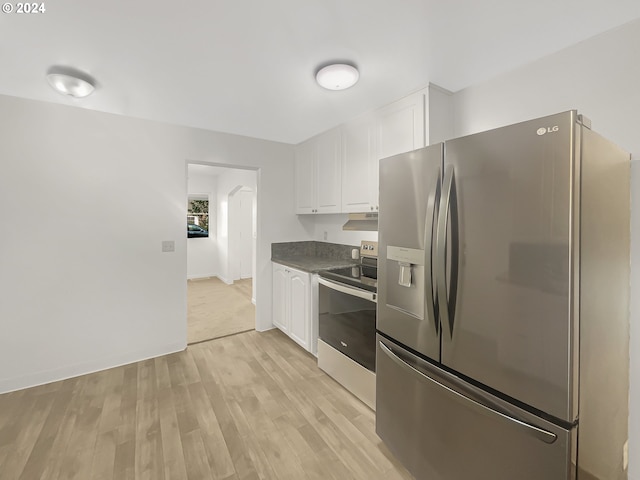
left=0, top=330, right=412, bottom=480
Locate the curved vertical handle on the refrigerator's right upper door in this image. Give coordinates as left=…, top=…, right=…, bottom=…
left=436, top=165, right=459, bottom=339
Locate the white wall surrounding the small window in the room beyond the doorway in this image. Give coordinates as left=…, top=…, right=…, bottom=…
left=187, top=167, right=218, bottom=278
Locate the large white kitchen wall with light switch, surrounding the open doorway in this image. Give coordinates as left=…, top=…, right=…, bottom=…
left=0, top=96, right=309, bottom=392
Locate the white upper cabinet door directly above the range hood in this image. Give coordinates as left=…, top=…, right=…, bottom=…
left=342, top=119, right=378, bottom=213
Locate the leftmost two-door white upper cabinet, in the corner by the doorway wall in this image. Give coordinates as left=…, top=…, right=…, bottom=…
left=295, top=128, right=342, bottom=213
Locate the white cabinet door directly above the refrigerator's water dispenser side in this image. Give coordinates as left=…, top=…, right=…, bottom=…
left=376, top=91, right=425, bottom=159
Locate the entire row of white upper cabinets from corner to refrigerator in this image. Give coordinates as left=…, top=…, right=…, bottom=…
left=295, top=88, right=430, bottom=213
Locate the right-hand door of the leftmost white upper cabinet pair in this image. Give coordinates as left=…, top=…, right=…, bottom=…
left=315, top=128, right=342, bottom=213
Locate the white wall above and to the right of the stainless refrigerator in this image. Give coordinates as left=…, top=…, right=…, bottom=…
left=454, top=21, right=640, bottom=480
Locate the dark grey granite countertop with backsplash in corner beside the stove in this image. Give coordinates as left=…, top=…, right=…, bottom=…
left=271, top=241, right=358, bottom=273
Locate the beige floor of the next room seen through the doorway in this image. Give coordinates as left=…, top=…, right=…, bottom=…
left=187, top=277, right=256, bottom=343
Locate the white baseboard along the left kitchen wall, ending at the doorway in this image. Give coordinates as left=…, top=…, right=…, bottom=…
left=0, top=341, right=187, bottom=394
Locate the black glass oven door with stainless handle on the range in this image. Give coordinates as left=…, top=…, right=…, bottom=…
left=318, top=277, right=376, bottom=372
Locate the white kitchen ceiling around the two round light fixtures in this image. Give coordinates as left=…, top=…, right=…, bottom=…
left=0, top=0, right=640, bottom=143
